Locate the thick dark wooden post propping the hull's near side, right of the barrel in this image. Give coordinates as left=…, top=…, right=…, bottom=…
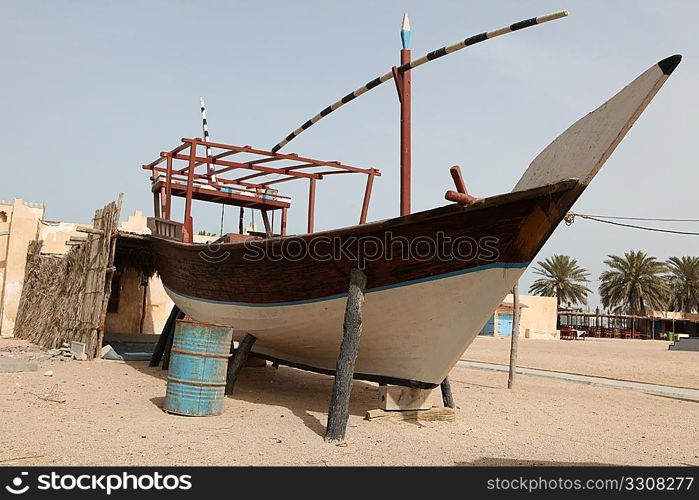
left=325, top=269, right=366, bottom=443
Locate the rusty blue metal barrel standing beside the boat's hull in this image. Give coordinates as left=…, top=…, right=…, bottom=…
left=164, top=320, right=233, bottom=417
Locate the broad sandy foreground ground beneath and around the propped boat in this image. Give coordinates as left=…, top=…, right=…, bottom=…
left=0, top=339, right=699, bottom=466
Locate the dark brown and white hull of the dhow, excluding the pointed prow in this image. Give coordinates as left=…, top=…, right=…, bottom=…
left=152, top=180, right=580, bottom=387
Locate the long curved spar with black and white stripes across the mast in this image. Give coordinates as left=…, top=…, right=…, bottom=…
left=272, top=10, right=568, bottom=153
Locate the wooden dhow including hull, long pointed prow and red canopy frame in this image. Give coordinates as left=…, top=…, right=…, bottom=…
left=139, top=10, right=680, bottom=388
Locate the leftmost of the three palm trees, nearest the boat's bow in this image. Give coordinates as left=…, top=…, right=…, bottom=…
left=529, top=255, right=591, bottom=306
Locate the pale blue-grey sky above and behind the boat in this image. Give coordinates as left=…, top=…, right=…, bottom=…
left=0, top=0, right=699, bottom=303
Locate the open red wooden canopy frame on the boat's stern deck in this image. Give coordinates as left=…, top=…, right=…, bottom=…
left=143, top=138, right=381, bottom=243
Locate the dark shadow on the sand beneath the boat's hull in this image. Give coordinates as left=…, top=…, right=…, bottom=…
left=125, top=361, right=378, bottom=436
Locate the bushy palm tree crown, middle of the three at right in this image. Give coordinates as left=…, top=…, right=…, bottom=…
left=599, top=250, right=670, bottom=315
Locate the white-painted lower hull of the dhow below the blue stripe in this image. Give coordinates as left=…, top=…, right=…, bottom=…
left=167, top=264, right=526, bottom=385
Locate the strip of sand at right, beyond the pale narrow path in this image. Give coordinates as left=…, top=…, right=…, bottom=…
left=461, top=336, right=699, bottom=389
